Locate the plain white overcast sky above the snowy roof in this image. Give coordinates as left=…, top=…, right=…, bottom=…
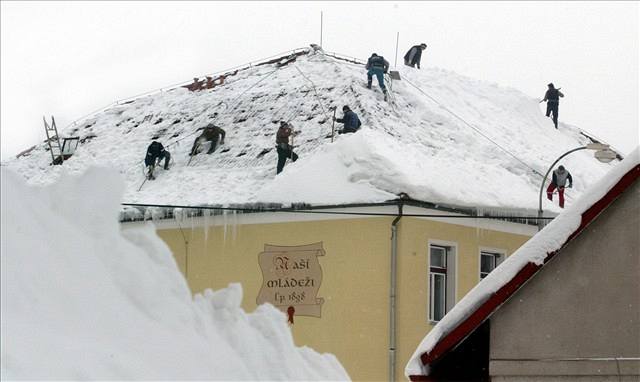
left=0, top=1, right=640, bottom=159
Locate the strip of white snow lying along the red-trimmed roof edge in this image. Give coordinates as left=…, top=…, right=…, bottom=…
left=405, top=147, right=640, bottom=378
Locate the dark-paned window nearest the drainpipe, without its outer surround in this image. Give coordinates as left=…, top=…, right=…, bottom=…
left=429, top=245, right=449, bottom=321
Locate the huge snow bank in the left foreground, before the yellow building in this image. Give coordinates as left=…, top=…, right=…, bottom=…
left=1, top=168, right=349, bottom=380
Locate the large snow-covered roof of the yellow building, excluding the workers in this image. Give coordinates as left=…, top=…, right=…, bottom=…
left=4, top=47, right=610, bottom=211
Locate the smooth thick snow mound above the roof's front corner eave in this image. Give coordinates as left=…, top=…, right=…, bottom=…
left=256, top=129, right=537, bottom=209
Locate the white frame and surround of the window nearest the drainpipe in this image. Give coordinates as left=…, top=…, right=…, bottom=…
left=426, top=239, right=458, bottom=324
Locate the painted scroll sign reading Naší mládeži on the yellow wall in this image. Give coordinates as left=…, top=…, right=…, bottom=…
left=256, top=242, right=325, bottom=323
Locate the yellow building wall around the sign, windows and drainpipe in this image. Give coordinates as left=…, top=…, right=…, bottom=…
left=158, top=217, right=528, bottom=381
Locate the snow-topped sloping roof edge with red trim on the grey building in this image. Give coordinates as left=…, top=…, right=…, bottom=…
left=405, top=147, right=640, bottom=378
